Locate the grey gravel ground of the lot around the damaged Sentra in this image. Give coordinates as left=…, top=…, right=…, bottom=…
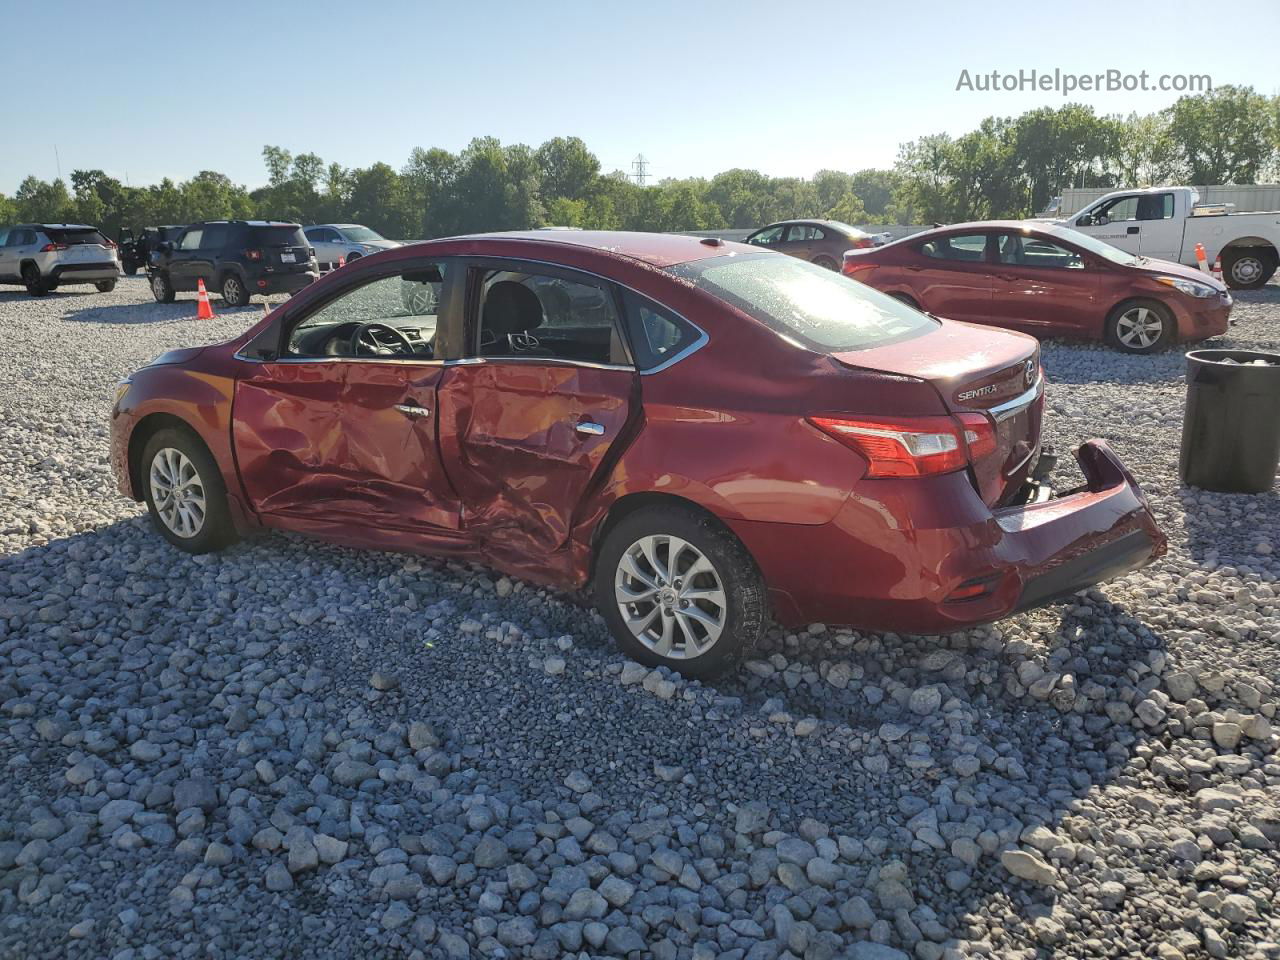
left=0, top=273, right=1280, bottom=960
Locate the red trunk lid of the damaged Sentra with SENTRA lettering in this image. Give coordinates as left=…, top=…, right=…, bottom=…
left=832, top=320, right=1044, bottom=506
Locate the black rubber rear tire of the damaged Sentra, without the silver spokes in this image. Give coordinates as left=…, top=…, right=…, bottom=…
left=591, top=504, right=768, bottom=677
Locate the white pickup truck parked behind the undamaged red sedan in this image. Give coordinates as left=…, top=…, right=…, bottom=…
left=1053, top=187, right=1280, bottom=289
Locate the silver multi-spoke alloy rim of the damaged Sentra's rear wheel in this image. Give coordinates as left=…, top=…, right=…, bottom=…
left=613, top=534, right=728, bottom=660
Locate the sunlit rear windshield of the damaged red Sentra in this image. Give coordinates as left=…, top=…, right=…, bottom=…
left=671, top=253, right=938, bottom=352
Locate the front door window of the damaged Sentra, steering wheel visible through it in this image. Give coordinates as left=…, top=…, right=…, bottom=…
left=285, top=264, right=445, bottom=360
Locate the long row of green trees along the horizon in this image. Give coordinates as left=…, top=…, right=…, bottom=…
left=0, top=87, right=1280, bottom=239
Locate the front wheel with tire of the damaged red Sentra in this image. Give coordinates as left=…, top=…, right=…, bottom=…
left=138, top=429, right=237, bottom=553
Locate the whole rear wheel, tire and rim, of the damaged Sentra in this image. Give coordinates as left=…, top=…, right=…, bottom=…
left=593, top=506, right=765, bottom=677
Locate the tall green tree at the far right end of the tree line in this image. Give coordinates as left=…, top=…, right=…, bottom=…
left=1169, top=86, right=1280, bottom=184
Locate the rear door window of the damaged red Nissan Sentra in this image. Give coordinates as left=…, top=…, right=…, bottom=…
left=477, top=270, right=631, bottom=365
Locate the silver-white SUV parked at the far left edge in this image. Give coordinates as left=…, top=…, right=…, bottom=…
left=0, top=223, right=120, bottom=297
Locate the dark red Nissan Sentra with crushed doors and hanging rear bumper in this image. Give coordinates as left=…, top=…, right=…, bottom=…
left=111, top=232, right=1165, bottom=676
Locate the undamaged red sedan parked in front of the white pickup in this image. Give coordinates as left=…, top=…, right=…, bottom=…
left=841, top=220, right=1231, bottom=353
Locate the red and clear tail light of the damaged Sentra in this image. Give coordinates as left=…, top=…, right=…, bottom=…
left=809, top=413, right=996, bottom=476
